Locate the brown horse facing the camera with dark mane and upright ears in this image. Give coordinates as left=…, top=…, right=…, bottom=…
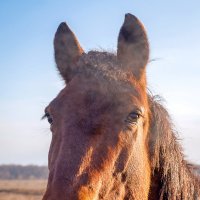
left=43, top=14, right=200, bottom=200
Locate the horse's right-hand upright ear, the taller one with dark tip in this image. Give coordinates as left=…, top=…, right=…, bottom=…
left=117, top=14, right=149, bottom=80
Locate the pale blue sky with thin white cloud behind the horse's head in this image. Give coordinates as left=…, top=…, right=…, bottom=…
left=0, top=0, right=200, bottom=165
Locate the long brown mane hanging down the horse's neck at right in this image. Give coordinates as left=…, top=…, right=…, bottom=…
left=149, top=95, right=200, bottom=200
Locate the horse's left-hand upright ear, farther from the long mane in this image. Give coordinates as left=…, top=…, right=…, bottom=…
left=54, top=22, right=84, bottom=82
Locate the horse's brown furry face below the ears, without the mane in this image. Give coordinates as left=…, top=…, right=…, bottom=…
left=44, top=52, right=150, bottom=200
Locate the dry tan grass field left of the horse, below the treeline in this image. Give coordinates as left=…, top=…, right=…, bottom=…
left=0, top=180, right=47, bottom=200
